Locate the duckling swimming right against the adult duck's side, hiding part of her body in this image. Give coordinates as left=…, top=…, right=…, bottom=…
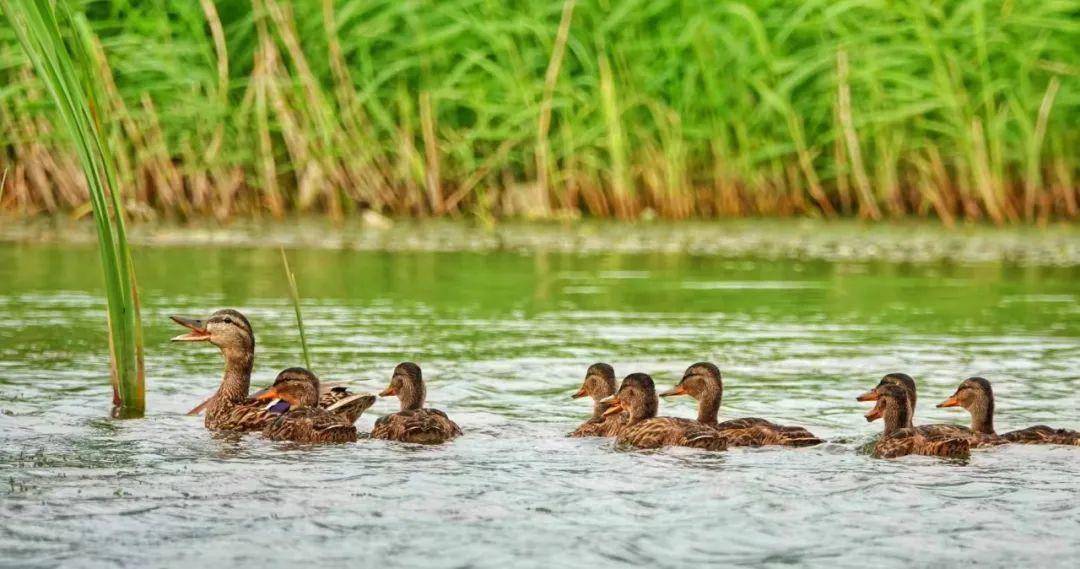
left=255, top=367, right=375, bottom=443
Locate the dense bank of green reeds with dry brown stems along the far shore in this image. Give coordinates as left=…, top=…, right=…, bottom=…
left=0, top=0, right=1080, bottom=223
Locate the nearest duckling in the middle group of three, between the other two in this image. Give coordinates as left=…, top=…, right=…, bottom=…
left=600, top=372, right=728, bottom=450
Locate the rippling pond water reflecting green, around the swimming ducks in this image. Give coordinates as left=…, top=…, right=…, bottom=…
left=0, top=244, right=1080, bottom=567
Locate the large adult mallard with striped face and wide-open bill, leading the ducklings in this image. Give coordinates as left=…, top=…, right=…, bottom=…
left=170, top=309, right=370, bottom=431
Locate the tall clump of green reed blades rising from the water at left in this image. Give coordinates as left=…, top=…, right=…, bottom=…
left=0, top=0, right=145, bottom=417
